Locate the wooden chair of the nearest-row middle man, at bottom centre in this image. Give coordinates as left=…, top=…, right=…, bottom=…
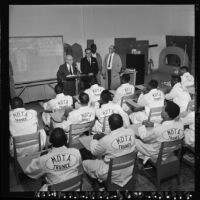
left=105, top=151, right=138, bottom=191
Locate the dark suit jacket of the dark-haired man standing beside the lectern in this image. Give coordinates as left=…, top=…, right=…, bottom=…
left=81, top=57, right=99, bottom=76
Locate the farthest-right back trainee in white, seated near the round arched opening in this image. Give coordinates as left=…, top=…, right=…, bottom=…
left=180, top=66, right=194, bottom=87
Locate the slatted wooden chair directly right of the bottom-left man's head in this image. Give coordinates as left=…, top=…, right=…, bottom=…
left=68, top=120, right=95, bottom=149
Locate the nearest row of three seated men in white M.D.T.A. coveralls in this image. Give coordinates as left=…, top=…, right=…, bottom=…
left=25, top=102, right=184, bottom=191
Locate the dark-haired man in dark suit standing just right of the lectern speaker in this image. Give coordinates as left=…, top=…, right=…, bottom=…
left=81, top=48, right=99, bottom=90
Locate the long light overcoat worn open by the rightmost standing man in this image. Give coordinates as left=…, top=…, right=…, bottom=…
left=102, top=53, right=122, bottom=90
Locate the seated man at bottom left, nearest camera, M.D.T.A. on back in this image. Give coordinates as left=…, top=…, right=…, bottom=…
left=25, top=128, right=82, bottom=191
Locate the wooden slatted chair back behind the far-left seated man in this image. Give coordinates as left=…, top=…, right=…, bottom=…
left=12, top=131, right=42, bottom=181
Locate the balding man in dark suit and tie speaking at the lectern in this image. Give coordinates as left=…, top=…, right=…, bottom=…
left=57, top=54, right=77, bottom=96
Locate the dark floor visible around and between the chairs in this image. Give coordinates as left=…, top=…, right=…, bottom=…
left=9, top=73, right=195, bottom=192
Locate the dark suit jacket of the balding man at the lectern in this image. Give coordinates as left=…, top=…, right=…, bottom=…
left=57, top=63, right=77, bottom=82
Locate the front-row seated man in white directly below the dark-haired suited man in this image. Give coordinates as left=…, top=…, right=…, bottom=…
left=85, top=76, right=105, bottom=109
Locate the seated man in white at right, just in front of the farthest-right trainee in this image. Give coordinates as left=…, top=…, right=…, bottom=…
left=165, top=75, right=191, bottom=113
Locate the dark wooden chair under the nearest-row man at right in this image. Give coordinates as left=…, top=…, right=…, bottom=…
left=146, top=139, right=183, bottom=190
